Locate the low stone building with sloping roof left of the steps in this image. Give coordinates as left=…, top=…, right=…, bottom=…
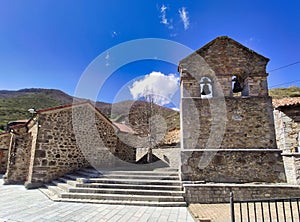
left=0, top=102, right=136, bottom=188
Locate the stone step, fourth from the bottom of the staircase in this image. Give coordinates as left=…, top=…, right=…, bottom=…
left=75, top=183, right=182, bottom=191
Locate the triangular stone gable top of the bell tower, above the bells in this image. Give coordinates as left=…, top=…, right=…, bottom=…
left=179, top=36, right=269, bottom=76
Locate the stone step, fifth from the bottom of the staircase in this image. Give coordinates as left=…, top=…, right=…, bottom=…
left=85, top=177, right=181, bottom=186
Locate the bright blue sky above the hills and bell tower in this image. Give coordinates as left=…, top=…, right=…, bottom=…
left=0, top=0, right=300, bottom=105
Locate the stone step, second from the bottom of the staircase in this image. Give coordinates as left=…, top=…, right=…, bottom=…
left=60, top=192, right=184, bottom=202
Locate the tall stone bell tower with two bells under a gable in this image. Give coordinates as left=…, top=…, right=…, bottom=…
left=178, top=36, right=286, bottom=183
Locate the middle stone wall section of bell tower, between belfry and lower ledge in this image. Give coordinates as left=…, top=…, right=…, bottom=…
left=182, top=97, right=276, bottom=149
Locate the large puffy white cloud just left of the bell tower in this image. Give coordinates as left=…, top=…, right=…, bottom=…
left=129, top=71, right=179, bottom=106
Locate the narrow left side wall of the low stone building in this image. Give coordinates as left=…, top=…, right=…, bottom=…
left=4, top=126, right=32, bottom=184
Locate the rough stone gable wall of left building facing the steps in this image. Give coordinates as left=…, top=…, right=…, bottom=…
left=28, top=104, right=135, bottom=186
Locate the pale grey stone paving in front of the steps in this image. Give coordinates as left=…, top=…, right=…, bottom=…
left=0, top=176, right=194, bottom=222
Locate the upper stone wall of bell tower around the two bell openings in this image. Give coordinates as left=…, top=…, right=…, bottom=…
left=179, top=36, right=269, bottom=97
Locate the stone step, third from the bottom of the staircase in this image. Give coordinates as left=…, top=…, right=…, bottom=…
left=67, top=185, right=184, bottom=197
